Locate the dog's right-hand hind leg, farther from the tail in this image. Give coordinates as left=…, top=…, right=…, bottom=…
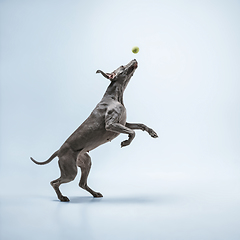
left=77, top=153, right=103, bottom=197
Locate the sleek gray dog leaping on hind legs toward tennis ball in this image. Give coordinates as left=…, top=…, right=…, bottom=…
left=31, top=59, right=158, bottom=202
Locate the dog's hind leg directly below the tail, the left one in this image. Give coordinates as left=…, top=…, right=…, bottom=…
left=51, top=147, right=77, bottom=202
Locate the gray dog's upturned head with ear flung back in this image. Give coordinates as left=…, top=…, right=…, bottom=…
left=96, top=59, right=138, bottom=85
